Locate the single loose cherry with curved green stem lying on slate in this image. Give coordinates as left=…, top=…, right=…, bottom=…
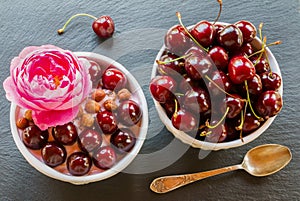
left=57, top=13, right=115, bottom=38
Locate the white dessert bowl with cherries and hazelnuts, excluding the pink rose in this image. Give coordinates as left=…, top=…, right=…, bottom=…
left=10, top=52, right=148, bottom=184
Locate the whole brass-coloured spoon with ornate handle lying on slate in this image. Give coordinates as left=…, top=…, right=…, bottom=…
left=150, top=144, right=292, bottom=193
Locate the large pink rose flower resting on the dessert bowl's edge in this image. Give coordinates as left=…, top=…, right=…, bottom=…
left=3, top=45, right=92, bottom=130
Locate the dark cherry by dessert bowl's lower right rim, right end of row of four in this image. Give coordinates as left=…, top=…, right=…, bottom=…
left=110, top=128, right=136, bottom=153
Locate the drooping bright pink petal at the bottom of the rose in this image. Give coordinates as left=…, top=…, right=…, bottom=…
left=32, top=106, right=79, bottom=130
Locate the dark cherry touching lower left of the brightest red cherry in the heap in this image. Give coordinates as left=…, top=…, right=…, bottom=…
left=207, top=70, right=233, bottom=95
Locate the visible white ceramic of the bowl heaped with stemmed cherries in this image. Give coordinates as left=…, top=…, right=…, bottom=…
left=151, top=22, right=283, bottom=151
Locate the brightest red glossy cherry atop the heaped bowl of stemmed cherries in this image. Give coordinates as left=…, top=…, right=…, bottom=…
left=228, top=56, right=255, bottom=84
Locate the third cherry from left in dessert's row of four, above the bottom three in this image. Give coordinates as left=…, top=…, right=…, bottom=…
left=78, top=129, right=103, bottom=152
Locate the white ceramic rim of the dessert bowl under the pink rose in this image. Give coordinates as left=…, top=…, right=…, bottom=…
left=10, top=52, right=148, bottom=184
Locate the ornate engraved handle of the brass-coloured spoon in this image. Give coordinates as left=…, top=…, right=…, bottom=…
left=150, top=165, right=242, bottom=193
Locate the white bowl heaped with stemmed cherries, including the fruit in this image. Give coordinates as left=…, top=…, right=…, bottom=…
left=149, top=9, right=283, bottom=150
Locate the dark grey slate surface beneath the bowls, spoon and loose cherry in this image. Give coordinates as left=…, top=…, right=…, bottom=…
left=0, top=0, right=300, bottom=201
